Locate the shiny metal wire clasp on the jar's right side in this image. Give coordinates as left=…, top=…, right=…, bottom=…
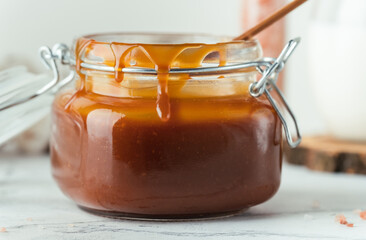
left=249, top=38, right=301, bottom=148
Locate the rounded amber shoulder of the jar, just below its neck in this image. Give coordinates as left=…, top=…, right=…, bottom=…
left=53, top=90, right=276, bottom=122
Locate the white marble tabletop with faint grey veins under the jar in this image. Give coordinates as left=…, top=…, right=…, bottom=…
left=0, top=156, right=366, bottom=240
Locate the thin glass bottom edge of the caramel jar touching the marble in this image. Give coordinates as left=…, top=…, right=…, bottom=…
left=78, top=205, right=248, bottom=222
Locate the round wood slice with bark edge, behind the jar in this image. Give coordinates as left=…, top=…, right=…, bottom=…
left=284, top=136, right=366, bottom=174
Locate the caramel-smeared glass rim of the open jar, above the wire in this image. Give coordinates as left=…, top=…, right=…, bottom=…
left=71, top=32, right=262, bottom=73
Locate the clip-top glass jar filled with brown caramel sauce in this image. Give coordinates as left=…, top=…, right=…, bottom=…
left=42, top=34, right=300, bottom=219
